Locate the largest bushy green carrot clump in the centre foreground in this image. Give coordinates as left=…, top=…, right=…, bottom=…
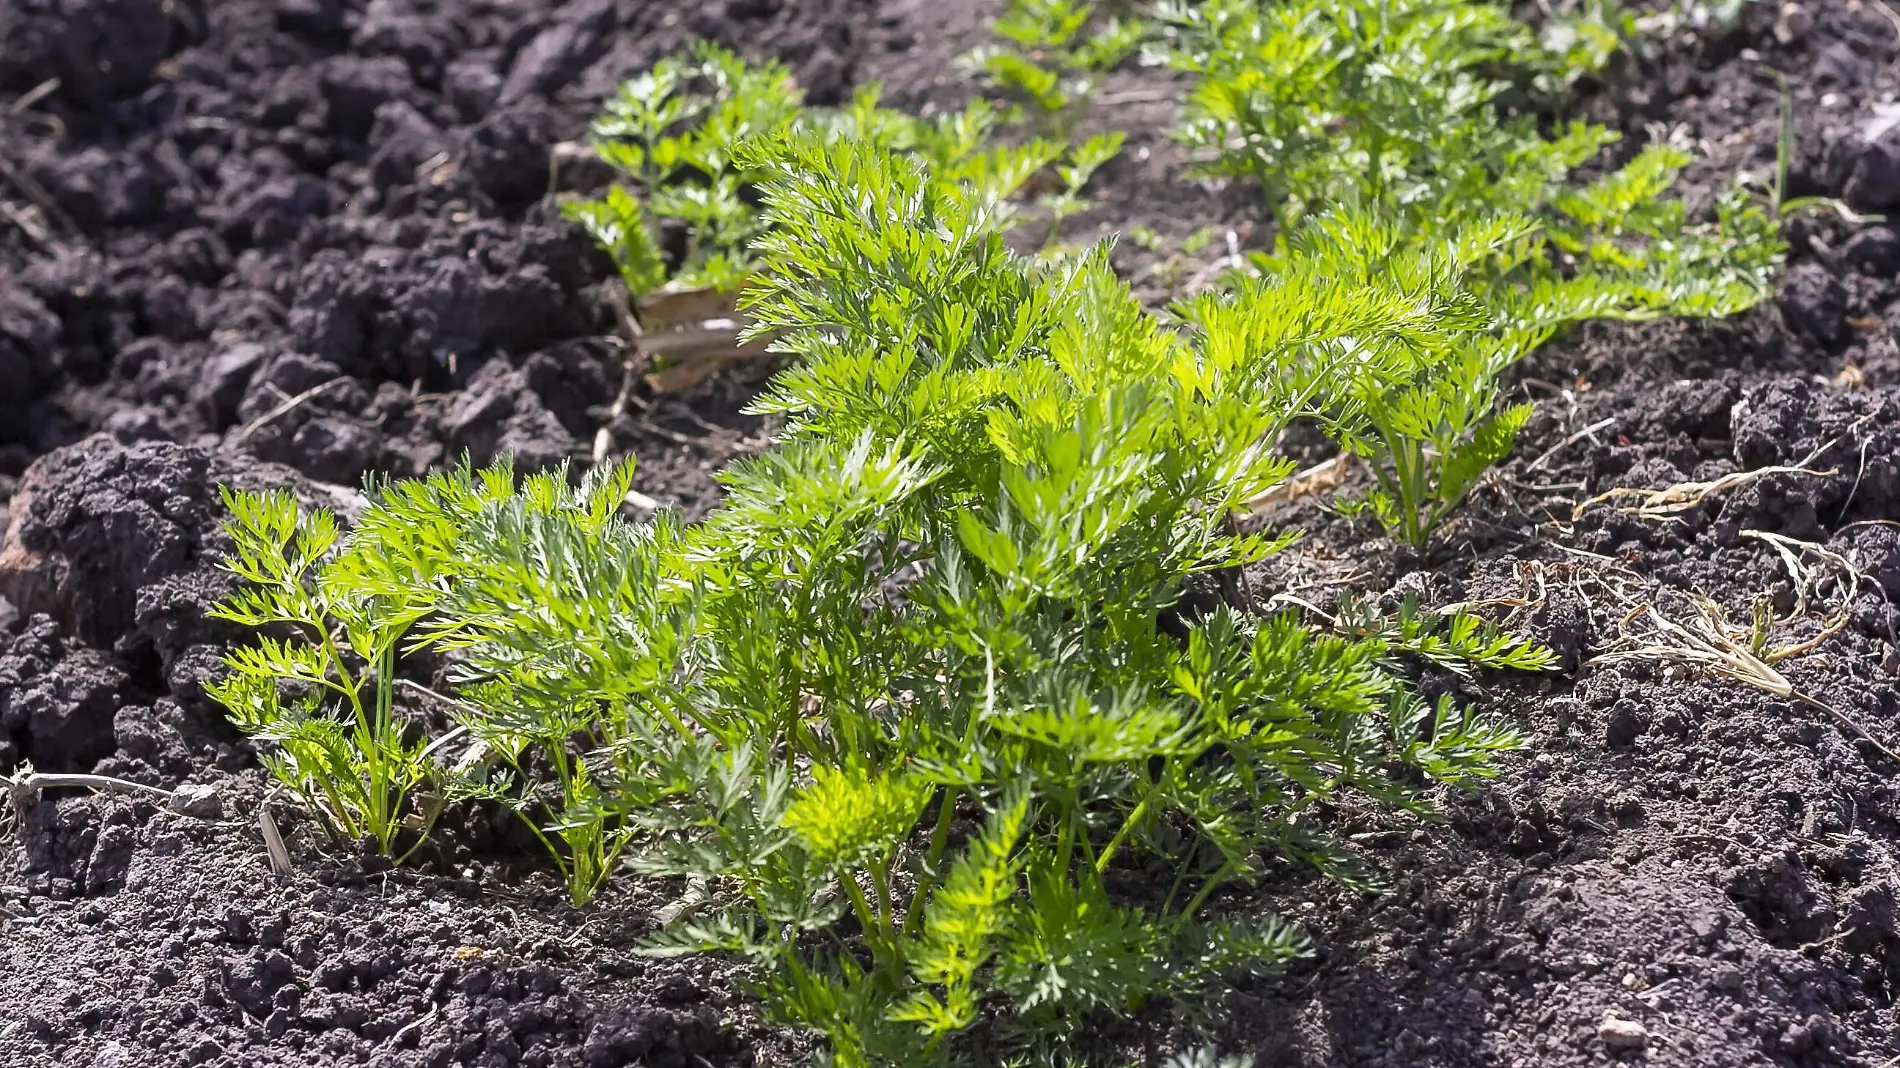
left=208, top=122, right=1545, bottom=1064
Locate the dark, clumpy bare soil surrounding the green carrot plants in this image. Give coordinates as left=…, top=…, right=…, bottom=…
left=0, top=0, right=1900, bottom=1068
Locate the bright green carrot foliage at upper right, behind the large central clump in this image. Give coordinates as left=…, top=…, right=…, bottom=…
left=1161, top=0, right=1782, bottom=545
